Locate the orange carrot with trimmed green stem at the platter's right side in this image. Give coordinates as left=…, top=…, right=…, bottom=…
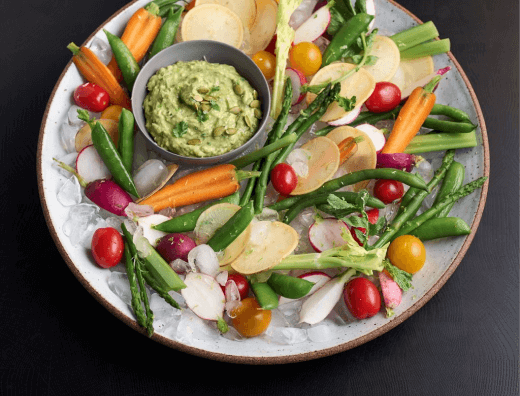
left=381, top=76, right=442, bottom=154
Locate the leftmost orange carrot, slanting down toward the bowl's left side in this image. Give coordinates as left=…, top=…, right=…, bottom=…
left=67, top=43, right=132, bottom=110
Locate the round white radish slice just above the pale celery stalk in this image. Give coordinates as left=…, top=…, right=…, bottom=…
left=309, top=217, right=348, bottom=253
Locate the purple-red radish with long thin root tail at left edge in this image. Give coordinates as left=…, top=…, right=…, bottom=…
left=53, top=158, right=134, bottom=216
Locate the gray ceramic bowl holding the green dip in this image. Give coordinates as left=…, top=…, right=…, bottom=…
left=132, top=40, right=271, bottom=165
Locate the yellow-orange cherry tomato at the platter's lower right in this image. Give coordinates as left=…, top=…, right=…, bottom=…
left=386, top=235, right=426, bottom=274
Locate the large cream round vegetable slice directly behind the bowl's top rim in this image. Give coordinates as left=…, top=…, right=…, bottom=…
left=181, top=4, right=244, bottom=48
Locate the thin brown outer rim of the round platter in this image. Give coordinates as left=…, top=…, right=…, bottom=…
left=37, top=0, right=490, bottom=365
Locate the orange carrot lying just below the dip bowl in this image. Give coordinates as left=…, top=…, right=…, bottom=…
left=139, top=164, right=260, bottom=212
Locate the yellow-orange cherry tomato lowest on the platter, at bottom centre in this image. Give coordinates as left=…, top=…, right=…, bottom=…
left=231, top=297, right=271, bottom=337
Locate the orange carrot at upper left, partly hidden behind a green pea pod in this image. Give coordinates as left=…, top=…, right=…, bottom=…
left=108, top=2, right=162, bottom=82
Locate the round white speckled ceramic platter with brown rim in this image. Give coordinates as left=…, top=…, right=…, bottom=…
left=37, top=0, right=489, bottom=364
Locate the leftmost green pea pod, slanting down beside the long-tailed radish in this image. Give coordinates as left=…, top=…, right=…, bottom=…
left=78, top=109, right=139, bottom=197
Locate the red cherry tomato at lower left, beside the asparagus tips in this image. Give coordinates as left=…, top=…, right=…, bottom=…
left=91, top=227, right=125, bottom=268
